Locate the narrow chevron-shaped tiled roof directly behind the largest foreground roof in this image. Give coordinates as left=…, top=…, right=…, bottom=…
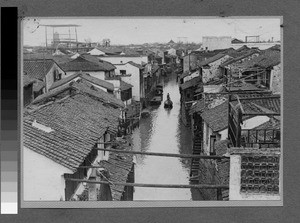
left=49, top=72, right=114, bottom=91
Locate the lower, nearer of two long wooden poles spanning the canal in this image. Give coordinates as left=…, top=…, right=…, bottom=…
left=66, top=178, right=229, bottom=189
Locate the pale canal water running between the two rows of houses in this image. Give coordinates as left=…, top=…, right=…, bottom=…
left=132, top=74, right=192, bottom=200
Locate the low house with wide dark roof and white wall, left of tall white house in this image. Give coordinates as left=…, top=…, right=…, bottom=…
left=60, top=55, right=115, bottom=80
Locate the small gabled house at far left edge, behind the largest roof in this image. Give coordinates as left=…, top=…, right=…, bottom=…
left=23, top=59, right=66, bottom=94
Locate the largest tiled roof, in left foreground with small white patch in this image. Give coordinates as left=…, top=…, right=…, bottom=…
left=23, top=93, right=120, bottom=172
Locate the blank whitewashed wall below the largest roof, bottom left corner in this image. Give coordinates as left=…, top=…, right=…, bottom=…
left=23, top=147, right=73, bottom=201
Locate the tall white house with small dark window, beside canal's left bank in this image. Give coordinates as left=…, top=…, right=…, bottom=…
left=114, top=61, right=145, bottom=101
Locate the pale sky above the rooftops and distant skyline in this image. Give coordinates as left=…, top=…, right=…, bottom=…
left=23, top=17, right=280, bottom=46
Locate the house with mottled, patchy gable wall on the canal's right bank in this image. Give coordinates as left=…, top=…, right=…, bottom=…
left=198, top=53, right=231, bottom=84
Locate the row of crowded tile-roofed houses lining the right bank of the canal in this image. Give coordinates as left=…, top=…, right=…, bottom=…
left=179, top=43, right=282, bottom=200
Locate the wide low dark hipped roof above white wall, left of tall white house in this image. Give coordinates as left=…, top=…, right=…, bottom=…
left=61, top=55, right=115, bottom=71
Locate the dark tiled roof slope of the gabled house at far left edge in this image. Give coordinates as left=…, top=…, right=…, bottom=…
left=23, top=59, right=54, bottom=80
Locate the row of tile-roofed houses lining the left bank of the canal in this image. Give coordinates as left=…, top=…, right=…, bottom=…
left=22, top=45, right=178, bottom=201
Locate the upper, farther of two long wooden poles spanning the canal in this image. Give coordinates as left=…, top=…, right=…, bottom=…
left=95, top=148, right=229, bottom=159
